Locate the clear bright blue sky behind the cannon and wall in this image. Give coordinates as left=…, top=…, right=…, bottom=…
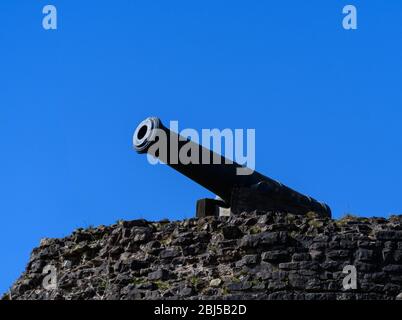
left=0, top=0, right=402, bottom=292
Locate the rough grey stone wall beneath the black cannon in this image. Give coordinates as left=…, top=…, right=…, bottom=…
left=3, top=212, right=402, bottom=300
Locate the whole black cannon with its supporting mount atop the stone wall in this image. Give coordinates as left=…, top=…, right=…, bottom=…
left=133, top=117, right=331, bottom=217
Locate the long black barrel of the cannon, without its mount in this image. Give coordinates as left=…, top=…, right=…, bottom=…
left=133, top=117, right=331, bottom=216
